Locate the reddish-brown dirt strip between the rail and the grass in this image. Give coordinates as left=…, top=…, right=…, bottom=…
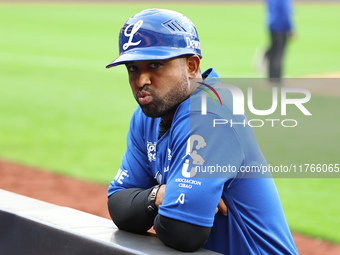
left=0, top=160, right=340, bottom=255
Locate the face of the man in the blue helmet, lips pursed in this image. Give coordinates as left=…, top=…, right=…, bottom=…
left=126, top=57, right=189, bottom=117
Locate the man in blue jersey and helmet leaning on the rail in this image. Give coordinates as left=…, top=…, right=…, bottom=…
left=107, top=9, right=297, bottom=254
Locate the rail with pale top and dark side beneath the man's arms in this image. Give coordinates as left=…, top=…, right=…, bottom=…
left=0, top=189, right=217, bottom=255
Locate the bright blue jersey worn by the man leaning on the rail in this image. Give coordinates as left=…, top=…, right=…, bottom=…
left=108, top=69, right=297, bottom=254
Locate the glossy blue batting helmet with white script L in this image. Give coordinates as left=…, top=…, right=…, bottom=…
left=106, top=9, right=202, bottom=68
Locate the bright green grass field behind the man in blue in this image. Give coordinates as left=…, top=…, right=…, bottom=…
left=0, top=3, right=340, bottom=243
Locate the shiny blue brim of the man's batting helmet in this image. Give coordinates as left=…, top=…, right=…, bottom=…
left=106, top=47, right=201, bottom=68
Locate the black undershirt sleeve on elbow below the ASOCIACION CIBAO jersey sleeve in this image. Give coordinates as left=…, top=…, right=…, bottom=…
left=154, top=214, right=211, bottom=252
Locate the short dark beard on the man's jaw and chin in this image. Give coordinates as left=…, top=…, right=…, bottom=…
left=136, top=73, right=189, bottom=118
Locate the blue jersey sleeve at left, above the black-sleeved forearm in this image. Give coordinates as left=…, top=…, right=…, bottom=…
left=108, top=107, right=155, bottom=196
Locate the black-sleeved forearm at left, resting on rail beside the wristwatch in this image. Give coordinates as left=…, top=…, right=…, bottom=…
left=108, top=188, right=157, bottom=233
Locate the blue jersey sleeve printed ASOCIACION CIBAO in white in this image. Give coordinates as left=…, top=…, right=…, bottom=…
left=159, top=110, right=244, bottom=227
